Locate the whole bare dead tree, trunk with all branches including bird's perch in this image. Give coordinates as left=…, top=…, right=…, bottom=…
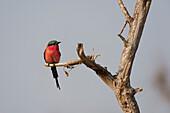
left=46, top=0, right=152, bottom=113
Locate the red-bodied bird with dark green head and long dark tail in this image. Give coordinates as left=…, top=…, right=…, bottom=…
left=44, top=40, right=61, bottom=90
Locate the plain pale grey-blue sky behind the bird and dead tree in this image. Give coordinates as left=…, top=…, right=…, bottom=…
left=0, top=0, right=170, bottom=113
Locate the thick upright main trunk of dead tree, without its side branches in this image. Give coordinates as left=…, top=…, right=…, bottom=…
left=113, top=0, right=151, bottom=113
